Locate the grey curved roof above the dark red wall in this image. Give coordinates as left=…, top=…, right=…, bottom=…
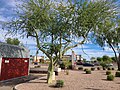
left=0, top=42, right=29, bottom=58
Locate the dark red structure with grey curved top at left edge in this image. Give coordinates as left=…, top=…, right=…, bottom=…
left=0, top=43, right=29, bottom=81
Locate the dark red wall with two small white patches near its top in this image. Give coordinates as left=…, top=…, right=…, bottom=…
left=0, top=58, right=29, bottom=81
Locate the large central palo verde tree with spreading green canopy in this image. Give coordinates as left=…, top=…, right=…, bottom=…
left=5, top=0, right=117, bottom=83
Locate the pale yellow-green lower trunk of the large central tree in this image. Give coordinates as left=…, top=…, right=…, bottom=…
left=47, top=59, right=54, bottom=84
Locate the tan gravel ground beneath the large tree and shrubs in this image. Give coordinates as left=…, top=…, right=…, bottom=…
left=16, top=70, right=120, bottom=90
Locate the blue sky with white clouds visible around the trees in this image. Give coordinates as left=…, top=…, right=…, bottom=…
left=0, top=0, right=114, bottom=60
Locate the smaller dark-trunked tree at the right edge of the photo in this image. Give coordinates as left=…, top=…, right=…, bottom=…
left=92, top=21, right=120, bottom=70
